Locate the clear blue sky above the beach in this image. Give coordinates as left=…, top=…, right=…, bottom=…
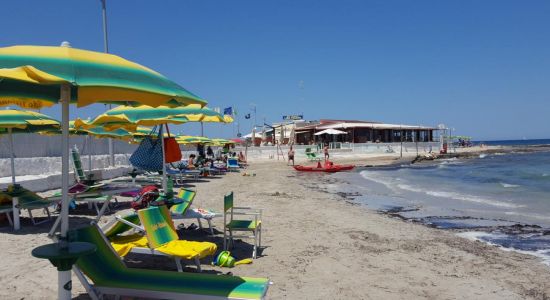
left=0, top=0, right=550, bottom=140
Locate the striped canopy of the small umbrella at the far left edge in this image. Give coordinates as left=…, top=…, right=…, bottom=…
left=0, top=109, right=59, bottom=134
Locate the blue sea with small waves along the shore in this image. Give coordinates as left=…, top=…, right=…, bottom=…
left=330, top=140, right=550, bottom=265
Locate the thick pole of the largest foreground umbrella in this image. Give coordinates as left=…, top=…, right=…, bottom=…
left=57, top=84, right=71, bottom=299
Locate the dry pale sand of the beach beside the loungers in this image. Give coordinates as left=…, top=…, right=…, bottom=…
left=0, top=154, right=550, bottom=299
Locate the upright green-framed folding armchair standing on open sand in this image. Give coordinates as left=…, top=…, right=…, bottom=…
left=223, top=192, right=262, bottom=259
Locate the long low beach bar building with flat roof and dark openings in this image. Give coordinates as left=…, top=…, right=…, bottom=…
left=294, top=119, right=438, bottom=145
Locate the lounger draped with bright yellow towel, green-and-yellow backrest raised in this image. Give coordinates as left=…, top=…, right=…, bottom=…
left=106, top=206, right=217, bottom=272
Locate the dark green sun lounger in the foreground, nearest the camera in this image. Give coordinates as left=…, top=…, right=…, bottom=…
left=68, top=225, right=270, bottom=299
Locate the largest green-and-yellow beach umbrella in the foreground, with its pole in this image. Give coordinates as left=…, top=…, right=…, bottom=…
left=0, top=42, right=206, bottom=299
